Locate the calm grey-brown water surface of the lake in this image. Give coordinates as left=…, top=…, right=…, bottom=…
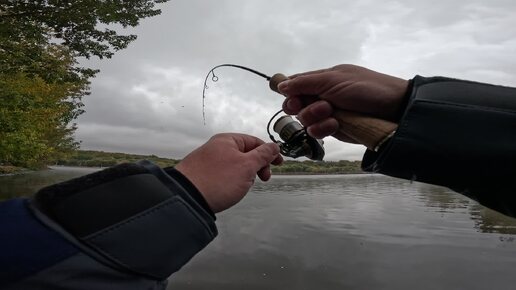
left=0, top=168, right=516, bottom=290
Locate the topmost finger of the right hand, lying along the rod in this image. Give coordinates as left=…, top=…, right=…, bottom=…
left=278, top=71, right=334, bottom=96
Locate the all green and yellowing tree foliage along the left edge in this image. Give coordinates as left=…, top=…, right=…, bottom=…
left=0, top=0, right=168, bottom=168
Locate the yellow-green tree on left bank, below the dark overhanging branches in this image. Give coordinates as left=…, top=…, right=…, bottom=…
left=0, top=45, right=88, bottom=167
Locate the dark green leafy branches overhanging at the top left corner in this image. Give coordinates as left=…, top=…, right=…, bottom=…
left=0, top=0, right=169, bottom=58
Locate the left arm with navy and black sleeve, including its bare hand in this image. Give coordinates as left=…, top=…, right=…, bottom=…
left=0, top=134, right=281, bottom=289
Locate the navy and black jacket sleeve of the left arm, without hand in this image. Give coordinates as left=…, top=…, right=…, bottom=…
left=0, top=162, right=217, bottom=289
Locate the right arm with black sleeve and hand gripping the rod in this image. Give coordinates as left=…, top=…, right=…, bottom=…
left=279, top=65, right=516, bottom=216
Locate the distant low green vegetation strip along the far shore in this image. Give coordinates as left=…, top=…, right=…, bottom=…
left=49, top=150, right=362, bottom=174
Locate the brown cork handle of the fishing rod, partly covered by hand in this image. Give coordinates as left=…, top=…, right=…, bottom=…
left=269, top=73, right=398, bottom=151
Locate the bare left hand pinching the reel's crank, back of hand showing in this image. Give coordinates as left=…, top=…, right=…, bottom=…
left=175, top=133, right=283, bottom=213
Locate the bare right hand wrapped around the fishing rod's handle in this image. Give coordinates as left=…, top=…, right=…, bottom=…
left=278, top=65, right=408, bottom=143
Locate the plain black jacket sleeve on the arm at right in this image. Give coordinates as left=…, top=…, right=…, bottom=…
left=362, top=76, right=516, bottom=216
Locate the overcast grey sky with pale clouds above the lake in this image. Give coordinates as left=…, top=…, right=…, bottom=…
left=76, top=0, right=516, bottom=160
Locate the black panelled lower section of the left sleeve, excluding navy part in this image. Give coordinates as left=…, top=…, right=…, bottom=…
left=32, top=161, right=217, bottom=280
